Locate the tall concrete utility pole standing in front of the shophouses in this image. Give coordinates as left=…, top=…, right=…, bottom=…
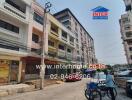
left=40, top=2, right=52, bottom=90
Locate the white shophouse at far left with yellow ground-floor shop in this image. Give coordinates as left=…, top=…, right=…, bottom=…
left=0, top=0, right=32, bottom=83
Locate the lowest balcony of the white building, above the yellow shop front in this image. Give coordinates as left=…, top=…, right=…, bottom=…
left=0, top=38, right=28, bottom=56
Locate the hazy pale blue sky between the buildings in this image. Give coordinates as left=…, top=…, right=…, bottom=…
left=38, top=0, right=126, bottom=64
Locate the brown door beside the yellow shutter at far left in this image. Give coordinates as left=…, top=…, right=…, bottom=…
left=10, top=61, right=19, bottom=82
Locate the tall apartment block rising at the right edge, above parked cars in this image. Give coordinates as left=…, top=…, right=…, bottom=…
left=119, top=0, right=132, bottom=64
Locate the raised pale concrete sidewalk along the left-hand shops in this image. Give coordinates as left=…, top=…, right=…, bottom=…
left=0, top=80, right=63, bottom=97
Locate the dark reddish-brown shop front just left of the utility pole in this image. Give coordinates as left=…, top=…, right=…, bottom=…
left=22, top=57, right=41, bottom=81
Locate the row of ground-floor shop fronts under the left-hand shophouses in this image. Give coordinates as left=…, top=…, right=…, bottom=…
left=0, top=56, right=81, bottom=84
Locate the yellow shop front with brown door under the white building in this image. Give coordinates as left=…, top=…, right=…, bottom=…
left=0, top=59, right=19, bottom=84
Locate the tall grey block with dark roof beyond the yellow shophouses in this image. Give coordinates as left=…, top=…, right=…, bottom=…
left=54, top=8, right=97, bottom=64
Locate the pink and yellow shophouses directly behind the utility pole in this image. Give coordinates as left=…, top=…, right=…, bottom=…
left=23, top=2, right=75, bottom=79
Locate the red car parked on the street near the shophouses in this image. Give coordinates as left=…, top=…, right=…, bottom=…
left=65, top=73, right=81, bottom=82
